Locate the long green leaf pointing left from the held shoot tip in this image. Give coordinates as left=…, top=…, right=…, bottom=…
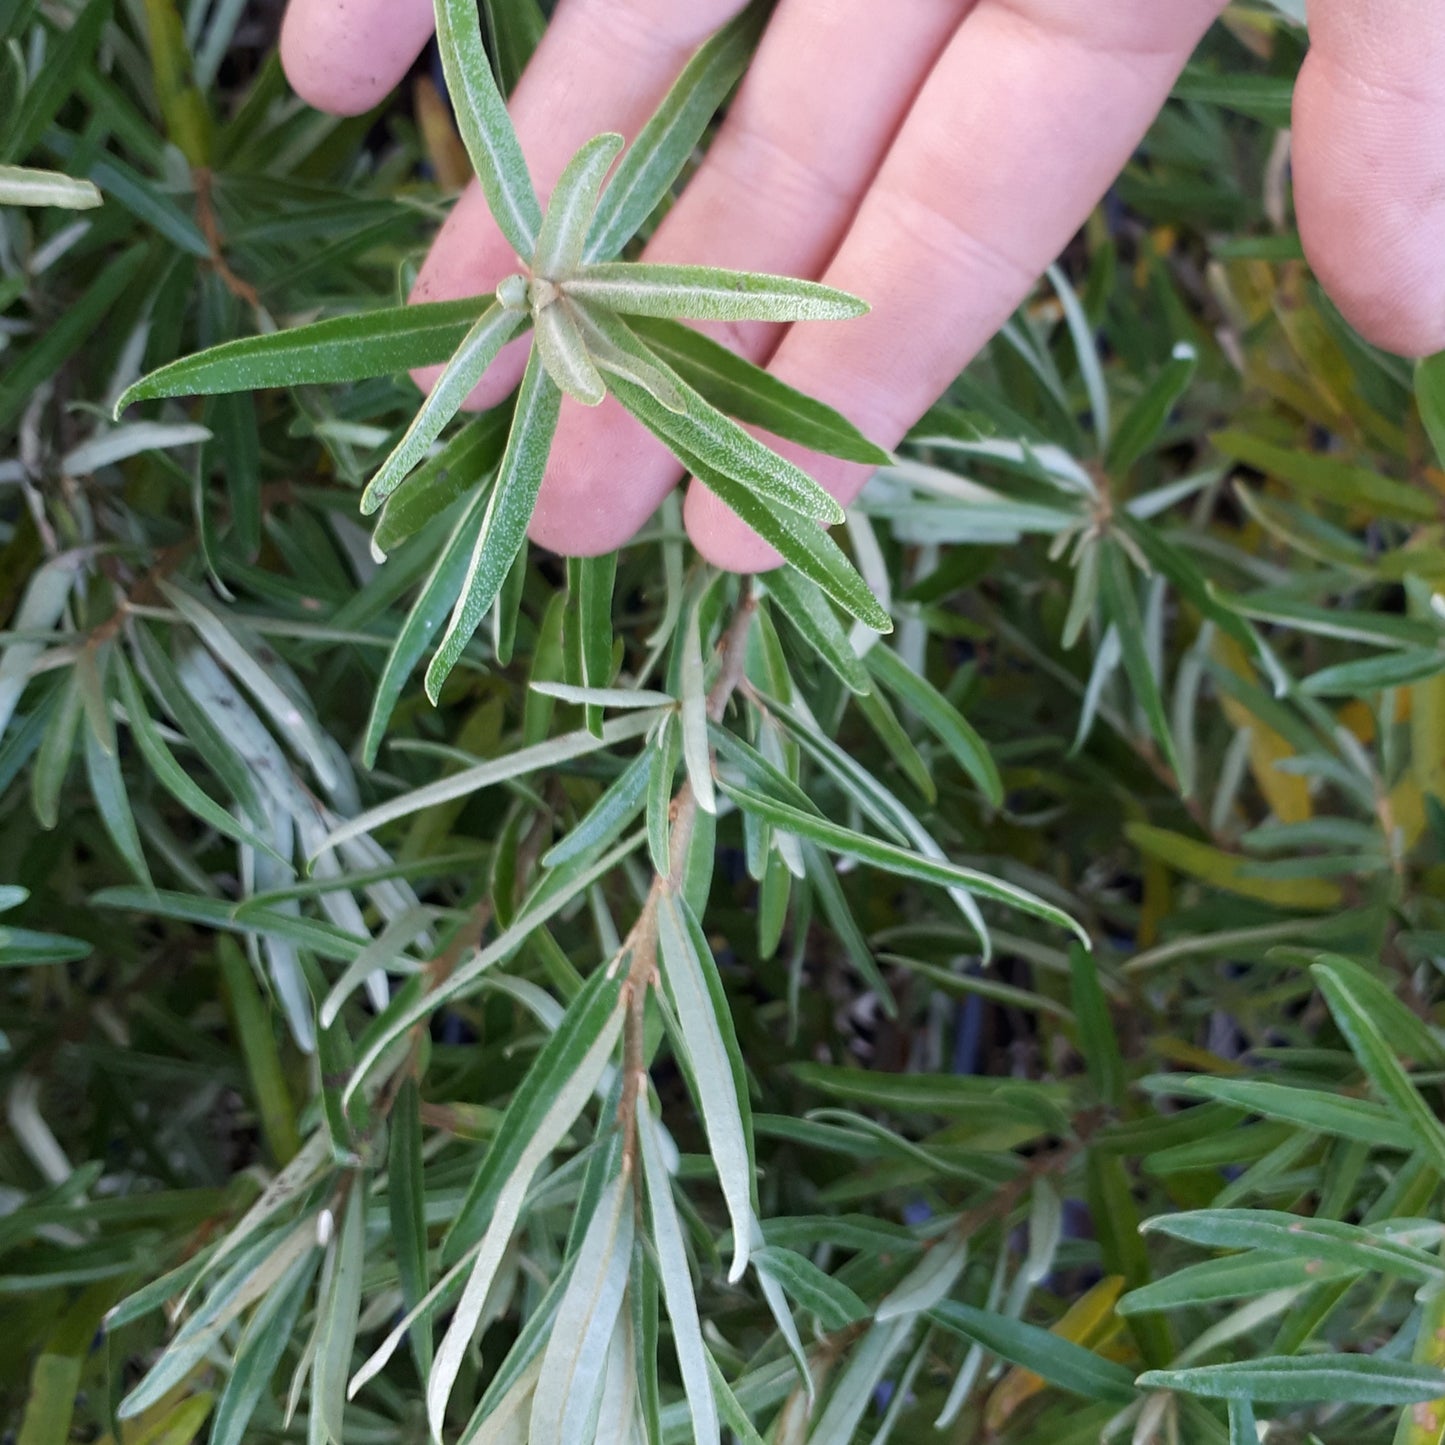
left=116, top=296, right=493, bottom=418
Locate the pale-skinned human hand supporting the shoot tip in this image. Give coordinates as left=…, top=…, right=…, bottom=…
left=282, top=0, right=1445, bottom=571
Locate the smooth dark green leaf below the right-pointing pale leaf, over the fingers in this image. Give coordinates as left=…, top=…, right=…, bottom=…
left=629, top=316, right=893, bottom=467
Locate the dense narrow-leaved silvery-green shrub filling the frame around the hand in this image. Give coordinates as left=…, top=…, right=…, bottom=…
left=0, top=0, right=1445, bottom=1445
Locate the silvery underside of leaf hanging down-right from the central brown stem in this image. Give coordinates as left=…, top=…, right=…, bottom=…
left=657, top=892, right=753, bottom=1283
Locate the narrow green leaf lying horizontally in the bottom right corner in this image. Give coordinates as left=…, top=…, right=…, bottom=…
left=1139, top=1354, right=1445, bottom=1405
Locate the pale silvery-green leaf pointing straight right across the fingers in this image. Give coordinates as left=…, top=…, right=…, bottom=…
left=566, top=262, right=868, bottom=321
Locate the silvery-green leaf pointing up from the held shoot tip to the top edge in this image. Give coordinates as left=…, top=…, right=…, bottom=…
left=436, top=0, right=542, bottom=259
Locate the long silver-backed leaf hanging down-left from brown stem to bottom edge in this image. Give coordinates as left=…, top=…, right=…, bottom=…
left=426, top=978, right=626, bottom=1436
